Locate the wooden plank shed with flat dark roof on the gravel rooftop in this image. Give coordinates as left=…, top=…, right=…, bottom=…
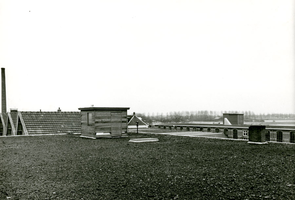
left=79, top=107, right=129, bottom=139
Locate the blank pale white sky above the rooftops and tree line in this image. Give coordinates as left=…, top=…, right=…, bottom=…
left=0, top=0, right=295, bottom=114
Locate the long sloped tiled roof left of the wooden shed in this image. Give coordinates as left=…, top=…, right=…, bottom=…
left=19, top=111, right=81, bottom=135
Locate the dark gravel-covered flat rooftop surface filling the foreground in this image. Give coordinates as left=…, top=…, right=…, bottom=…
left=0, top=134, right=295, bottom=199
